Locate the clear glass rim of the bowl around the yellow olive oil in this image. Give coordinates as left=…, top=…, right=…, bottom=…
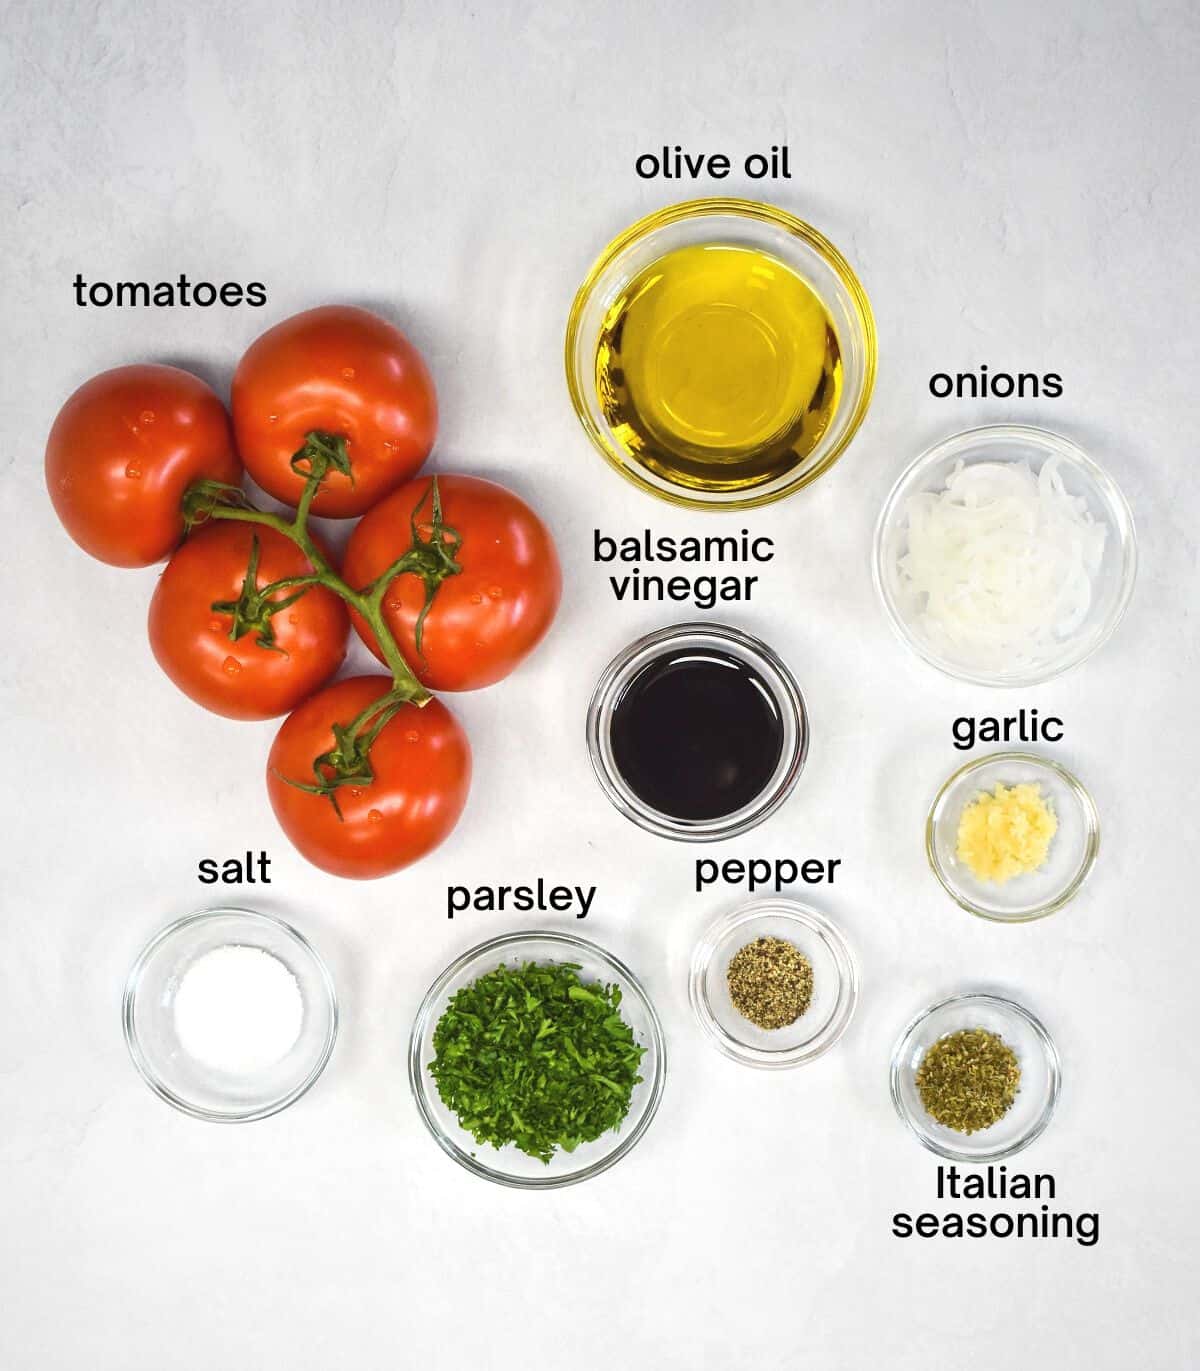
left=564, top=196, right=878, bottom=510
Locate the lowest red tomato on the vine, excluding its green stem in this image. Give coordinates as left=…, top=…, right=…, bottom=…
left=266, top=676, right=470, bottom=880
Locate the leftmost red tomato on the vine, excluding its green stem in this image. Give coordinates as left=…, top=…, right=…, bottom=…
left=45, top=366, right=241, bottom=566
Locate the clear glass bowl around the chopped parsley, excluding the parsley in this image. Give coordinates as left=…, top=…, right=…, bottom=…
left=409, top=931, right=667, bottom=1190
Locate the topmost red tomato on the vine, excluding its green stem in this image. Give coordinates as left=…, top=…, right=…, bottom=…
left=233, top=304, right=437, bottom=518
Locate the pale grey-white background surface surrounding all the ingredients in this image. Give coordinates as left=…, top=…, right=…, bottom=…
left=0, top=0, right=1200, bottom=1371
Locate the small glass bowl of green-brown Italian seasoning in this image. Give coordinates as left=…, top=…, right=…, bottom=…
left=891, top=993, right=1061, bottom=1161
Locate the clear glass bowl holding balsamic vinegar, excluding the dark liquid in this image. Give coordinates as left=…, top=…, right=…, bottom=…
left=587, top=621, right=809, bottom=843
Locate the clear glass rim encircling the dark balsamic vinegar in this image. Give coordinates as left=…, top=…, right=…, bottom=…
left=587, top=620, right=811, bottom=843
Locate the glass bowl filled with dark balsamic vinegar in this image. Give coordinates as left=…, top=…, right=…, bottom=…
left=587, top=622, right=809, bottom=842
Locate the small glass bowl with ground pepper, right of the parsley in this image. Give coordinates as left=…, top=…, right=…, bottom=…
left=688, top=898, right=859, bottom=1069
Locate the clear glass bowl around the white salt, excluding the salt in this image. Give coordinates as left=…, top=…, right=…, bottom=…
left=122, top=909, right=337, bottom=1123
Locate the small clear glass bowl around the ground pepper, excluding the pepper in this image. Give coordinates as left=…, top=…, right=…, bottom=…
left=688, top=897, right=859, bottom=1069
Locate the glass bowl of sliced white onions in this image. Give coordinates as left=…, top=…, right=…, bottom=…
left=874, top=424, right=1137, bottom=686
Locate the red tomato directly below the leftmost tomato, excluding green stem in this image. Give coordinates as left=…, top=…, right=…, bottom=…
left=149, top=522, right=350, bottom=718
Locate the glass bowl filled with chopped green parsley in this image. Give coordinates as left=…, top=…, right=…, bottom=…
left=409, top=931, right=667, bottom=1190
